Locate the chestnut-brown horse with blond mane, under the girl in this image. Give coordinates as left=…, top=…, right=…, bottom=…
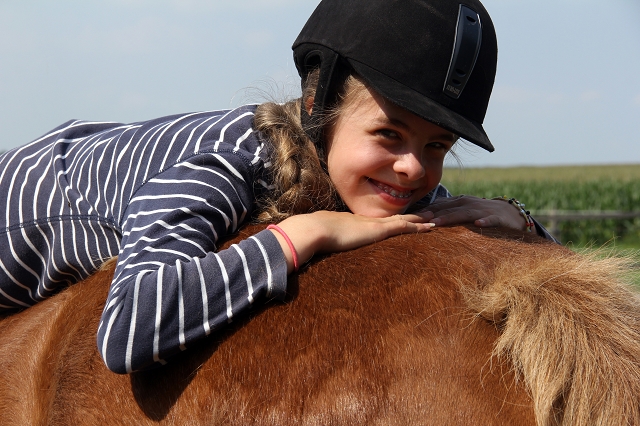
left=0, top=227, right=640, bottom=425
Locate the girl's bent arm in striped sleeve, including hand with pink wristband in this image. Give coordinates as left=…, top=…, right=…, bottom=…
left=98, top=154, right=433, bottom=373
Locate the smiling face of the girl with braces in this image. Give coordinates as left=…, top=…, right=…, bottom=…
left=327, top=89, right=456, bottom=217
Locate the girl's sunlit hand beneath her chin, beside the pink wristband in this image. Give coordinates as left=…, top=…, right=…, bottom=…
left=264, top=211, right=435, bottom=273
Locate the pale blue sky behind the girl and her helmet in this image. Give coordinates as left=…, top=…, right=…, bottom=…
left=0, top=0, right=640, bottom=167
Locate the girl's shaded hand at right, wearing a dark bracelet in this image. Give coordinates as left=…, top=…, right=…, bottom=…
left=423, top=195, right=527, bottom=231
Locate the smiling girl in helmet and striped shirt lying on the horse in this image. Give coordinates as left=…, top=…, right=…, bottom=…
left=0, top=0, right=551, bottom=373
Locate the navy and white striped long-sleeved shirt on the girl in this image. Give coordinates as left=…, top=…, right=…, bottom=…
left=0, top=106, right=286, bottom=373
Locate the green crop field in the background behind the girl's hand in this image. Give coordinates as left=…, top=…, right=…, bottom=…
left=442, top=164, right=640, bottom=286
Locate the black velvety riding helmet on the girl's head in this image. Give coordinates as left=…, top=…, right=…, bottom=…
left=293, top=0, right=498, bottom=155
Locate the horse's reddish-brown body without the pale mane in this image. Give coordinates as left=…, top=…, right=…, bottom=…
left=0, top=225, right=636, bottom=425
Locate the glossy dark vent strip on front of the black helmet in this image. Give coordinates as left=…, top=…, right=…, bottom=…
left=443, top=4, right=482, bottom=99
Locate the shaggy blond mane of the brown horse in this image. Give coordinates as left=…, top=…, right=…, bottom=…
left=458, top=228, right=640, bottom=425
